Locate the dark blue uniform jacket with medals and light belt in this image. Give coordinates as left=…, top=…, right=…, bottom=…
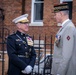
left=7, top=31, right=36, bottom=75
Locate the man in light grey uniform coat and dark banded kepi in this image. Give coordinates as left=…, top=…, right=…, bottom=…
left=51, top=3, right=75, bottom=75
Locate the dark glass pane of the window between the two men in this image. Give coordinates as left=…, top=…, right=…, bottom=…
left=34, top=3, right=43, bottom=21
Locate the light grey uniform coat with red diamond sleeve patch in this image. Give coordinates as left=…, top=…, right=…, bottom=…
left=51, top=20, right=75, bottom=75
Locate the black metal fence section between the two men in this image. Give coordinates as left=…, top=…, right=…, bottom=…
left=32, top=35, right=53, bottom=75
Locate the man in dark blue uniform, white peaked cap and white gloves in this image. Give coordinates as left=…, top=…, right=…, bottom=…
left=7, top=14, right=36, bottom=75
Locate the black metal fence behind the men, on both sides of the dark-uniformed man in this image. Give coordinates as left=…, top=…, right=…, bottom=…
left=0, top=28, right=53, bottom=75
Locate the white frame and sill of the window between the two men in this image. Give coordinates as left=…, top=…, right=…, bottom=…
left=30, top=0, right=43, bottom=26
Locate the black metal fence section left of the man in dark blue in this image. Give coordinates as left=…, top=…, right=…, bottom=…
left=0, top=26, right=10, bottom=75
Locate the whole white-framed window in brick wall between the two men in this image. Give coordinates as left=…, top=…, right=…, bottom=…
left=31, top=0, right=44, bottom=26
